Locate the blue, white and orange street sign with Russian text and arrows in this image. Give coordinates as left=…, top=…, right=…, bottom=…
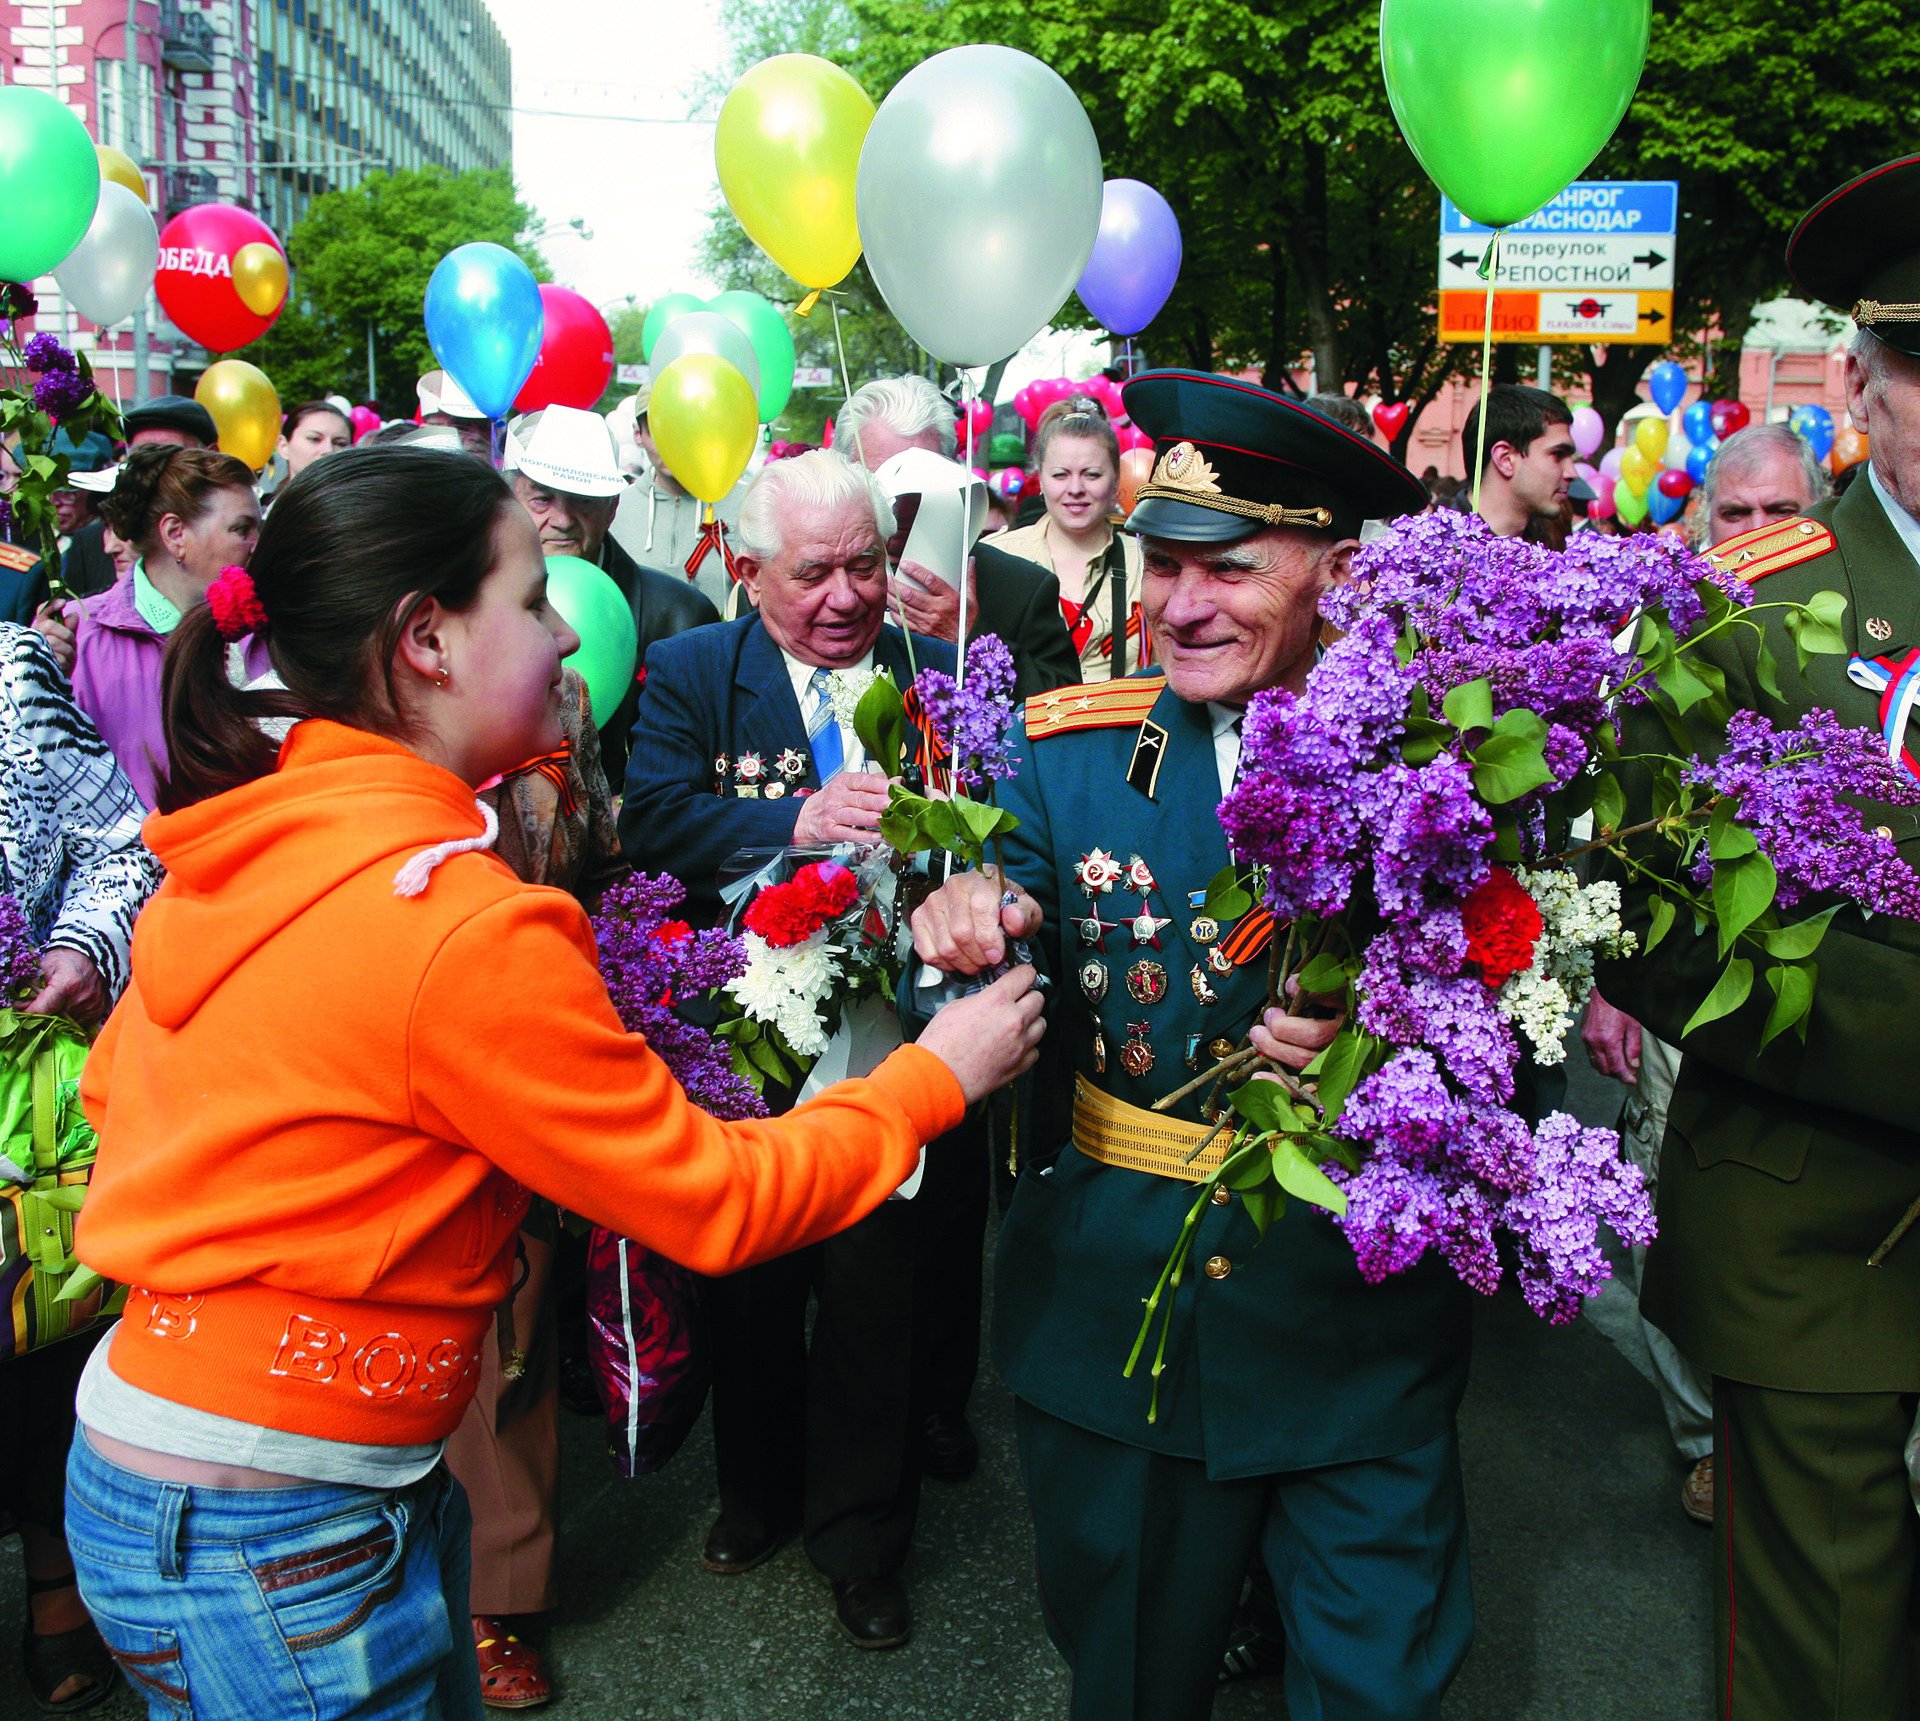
left=1440, top=179, right=1680, bottom=344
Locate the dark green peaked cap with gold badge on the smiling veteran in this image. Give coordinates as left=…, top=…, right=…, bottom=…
left=1121, top=371, right=1427, bottom=544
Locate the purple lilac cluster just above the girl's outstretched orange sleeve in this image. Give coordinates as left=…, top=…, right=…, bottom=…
left=593, top=872, right=766, bottom=1120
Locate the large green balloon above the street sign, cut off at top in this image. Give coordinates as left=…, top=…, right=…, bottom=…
left=1380, top=0, right=1651, bottom=227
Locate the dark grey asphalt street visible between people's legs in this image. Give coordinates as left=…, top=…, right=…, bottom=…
left=0, top=1044, right=1711, bottom=1721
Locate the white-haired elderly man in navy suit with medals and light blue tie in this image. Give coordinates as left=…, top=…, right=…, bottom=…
left=620, top=449, right=954, bottom=1648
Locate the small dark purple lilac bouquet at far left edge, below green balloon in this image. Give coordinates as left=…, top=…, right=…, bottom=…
left=0, top=280, right=121, bottom=597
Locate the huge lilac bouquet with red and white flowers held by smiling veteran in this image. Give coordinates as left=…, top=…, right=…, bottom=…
left=1129, top=511, right=1896, bottom=1390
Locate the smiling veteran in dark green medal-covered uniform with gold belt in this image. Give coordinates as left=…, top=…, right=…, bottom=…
left=914, top=371, right=1473, bottom=1721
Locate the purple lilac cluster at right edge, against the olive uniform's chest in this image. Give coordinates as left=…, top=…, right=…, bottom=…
left=1686, top=711, right=1920, bottom=920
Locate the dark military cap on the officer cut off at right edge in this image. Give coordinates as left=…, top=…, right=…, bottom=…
left=1788, top=156, right=1920, bottom=357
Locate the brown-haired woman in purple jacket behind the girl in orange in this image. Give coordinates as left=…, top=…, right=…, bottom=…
left=67, top=446, right=271, bottom=807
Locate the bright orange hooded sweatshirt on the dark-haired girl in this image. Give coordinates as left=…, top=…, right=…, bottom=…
left=79, top=720, right=964, bottom=1444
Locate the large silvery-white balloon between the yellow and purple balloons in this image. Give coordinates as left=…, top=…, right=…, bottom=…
left=854, top=46, right=1102, bottom=365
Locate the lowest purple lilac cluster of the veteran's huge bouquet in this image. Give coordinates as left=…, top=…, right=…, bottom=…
left=1327, top=1051, right=1655, bottom=1325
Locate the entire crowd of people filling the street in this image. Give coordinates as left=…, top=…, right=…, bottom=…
left=0, top=151, right=1920, bottom=1721
